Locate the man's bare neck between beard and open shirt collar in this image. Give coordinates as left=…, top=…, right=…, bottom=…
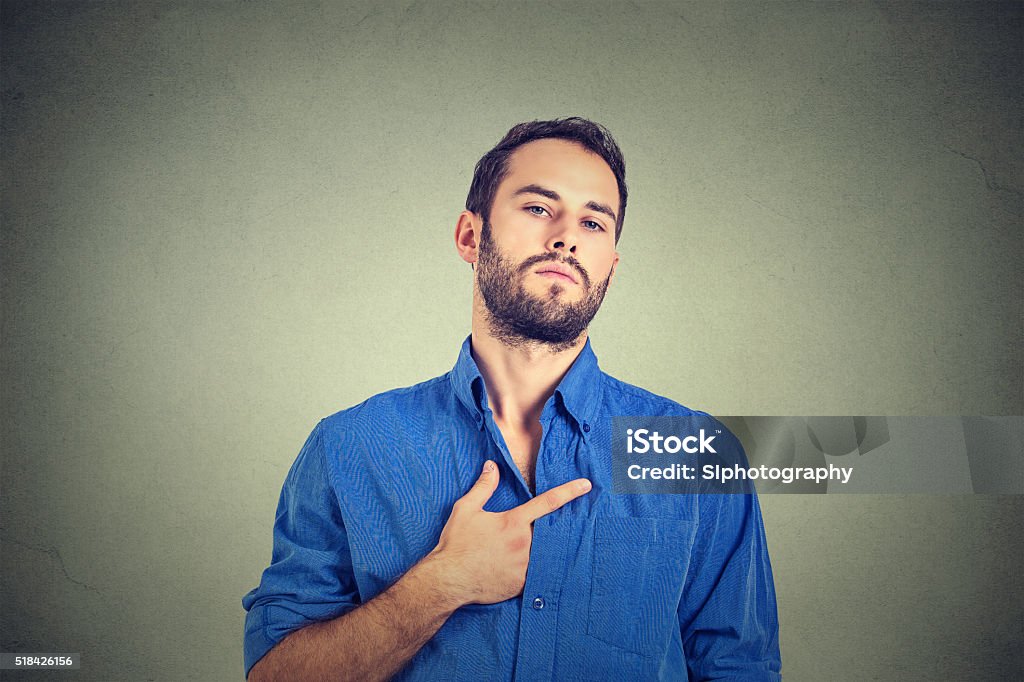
left=471, top=300, right=587, bottom=428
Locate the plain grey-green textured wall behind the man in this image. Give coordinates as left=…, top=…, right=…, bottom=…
left=0, top=0, right=1024, bottom=680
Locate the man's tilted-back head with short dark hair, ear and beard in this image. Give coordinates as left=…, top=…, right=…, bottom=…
left=456, top=119, right=626, bottom=349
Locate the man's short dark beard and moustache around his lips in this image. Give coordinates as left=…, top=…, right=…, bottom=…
left=476, top=221, right=611, bottom=351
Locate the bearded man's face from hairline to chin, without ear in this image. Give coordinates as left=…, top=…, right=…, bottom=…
left=468, top=139, right=618, bottom=346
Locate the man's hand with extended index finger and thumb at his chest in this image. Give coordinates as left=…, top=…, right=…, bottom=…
left=428, top=460, right=591, bottom=604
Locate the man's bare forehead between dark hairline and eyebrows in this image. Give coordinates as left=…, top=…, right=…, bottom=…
left=498, top=139, right=618, bottom=212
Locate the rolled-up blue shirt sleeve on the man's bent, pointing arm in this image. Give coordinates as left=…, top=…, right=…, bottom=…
left=242, top=422, right=359, bottom=677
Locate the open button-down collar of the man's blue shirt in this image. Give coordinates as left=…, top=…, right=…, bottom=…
left=450, top=336, right=602, bottom=438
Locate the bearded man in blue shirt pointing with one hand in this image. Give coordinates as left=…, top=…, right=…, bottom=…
left=243, top=118, right=780, bottom=680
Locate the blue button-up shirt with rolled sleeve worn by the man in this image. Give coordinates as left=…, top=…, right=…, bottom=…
left=242, top=338, right=781, bottom=681
